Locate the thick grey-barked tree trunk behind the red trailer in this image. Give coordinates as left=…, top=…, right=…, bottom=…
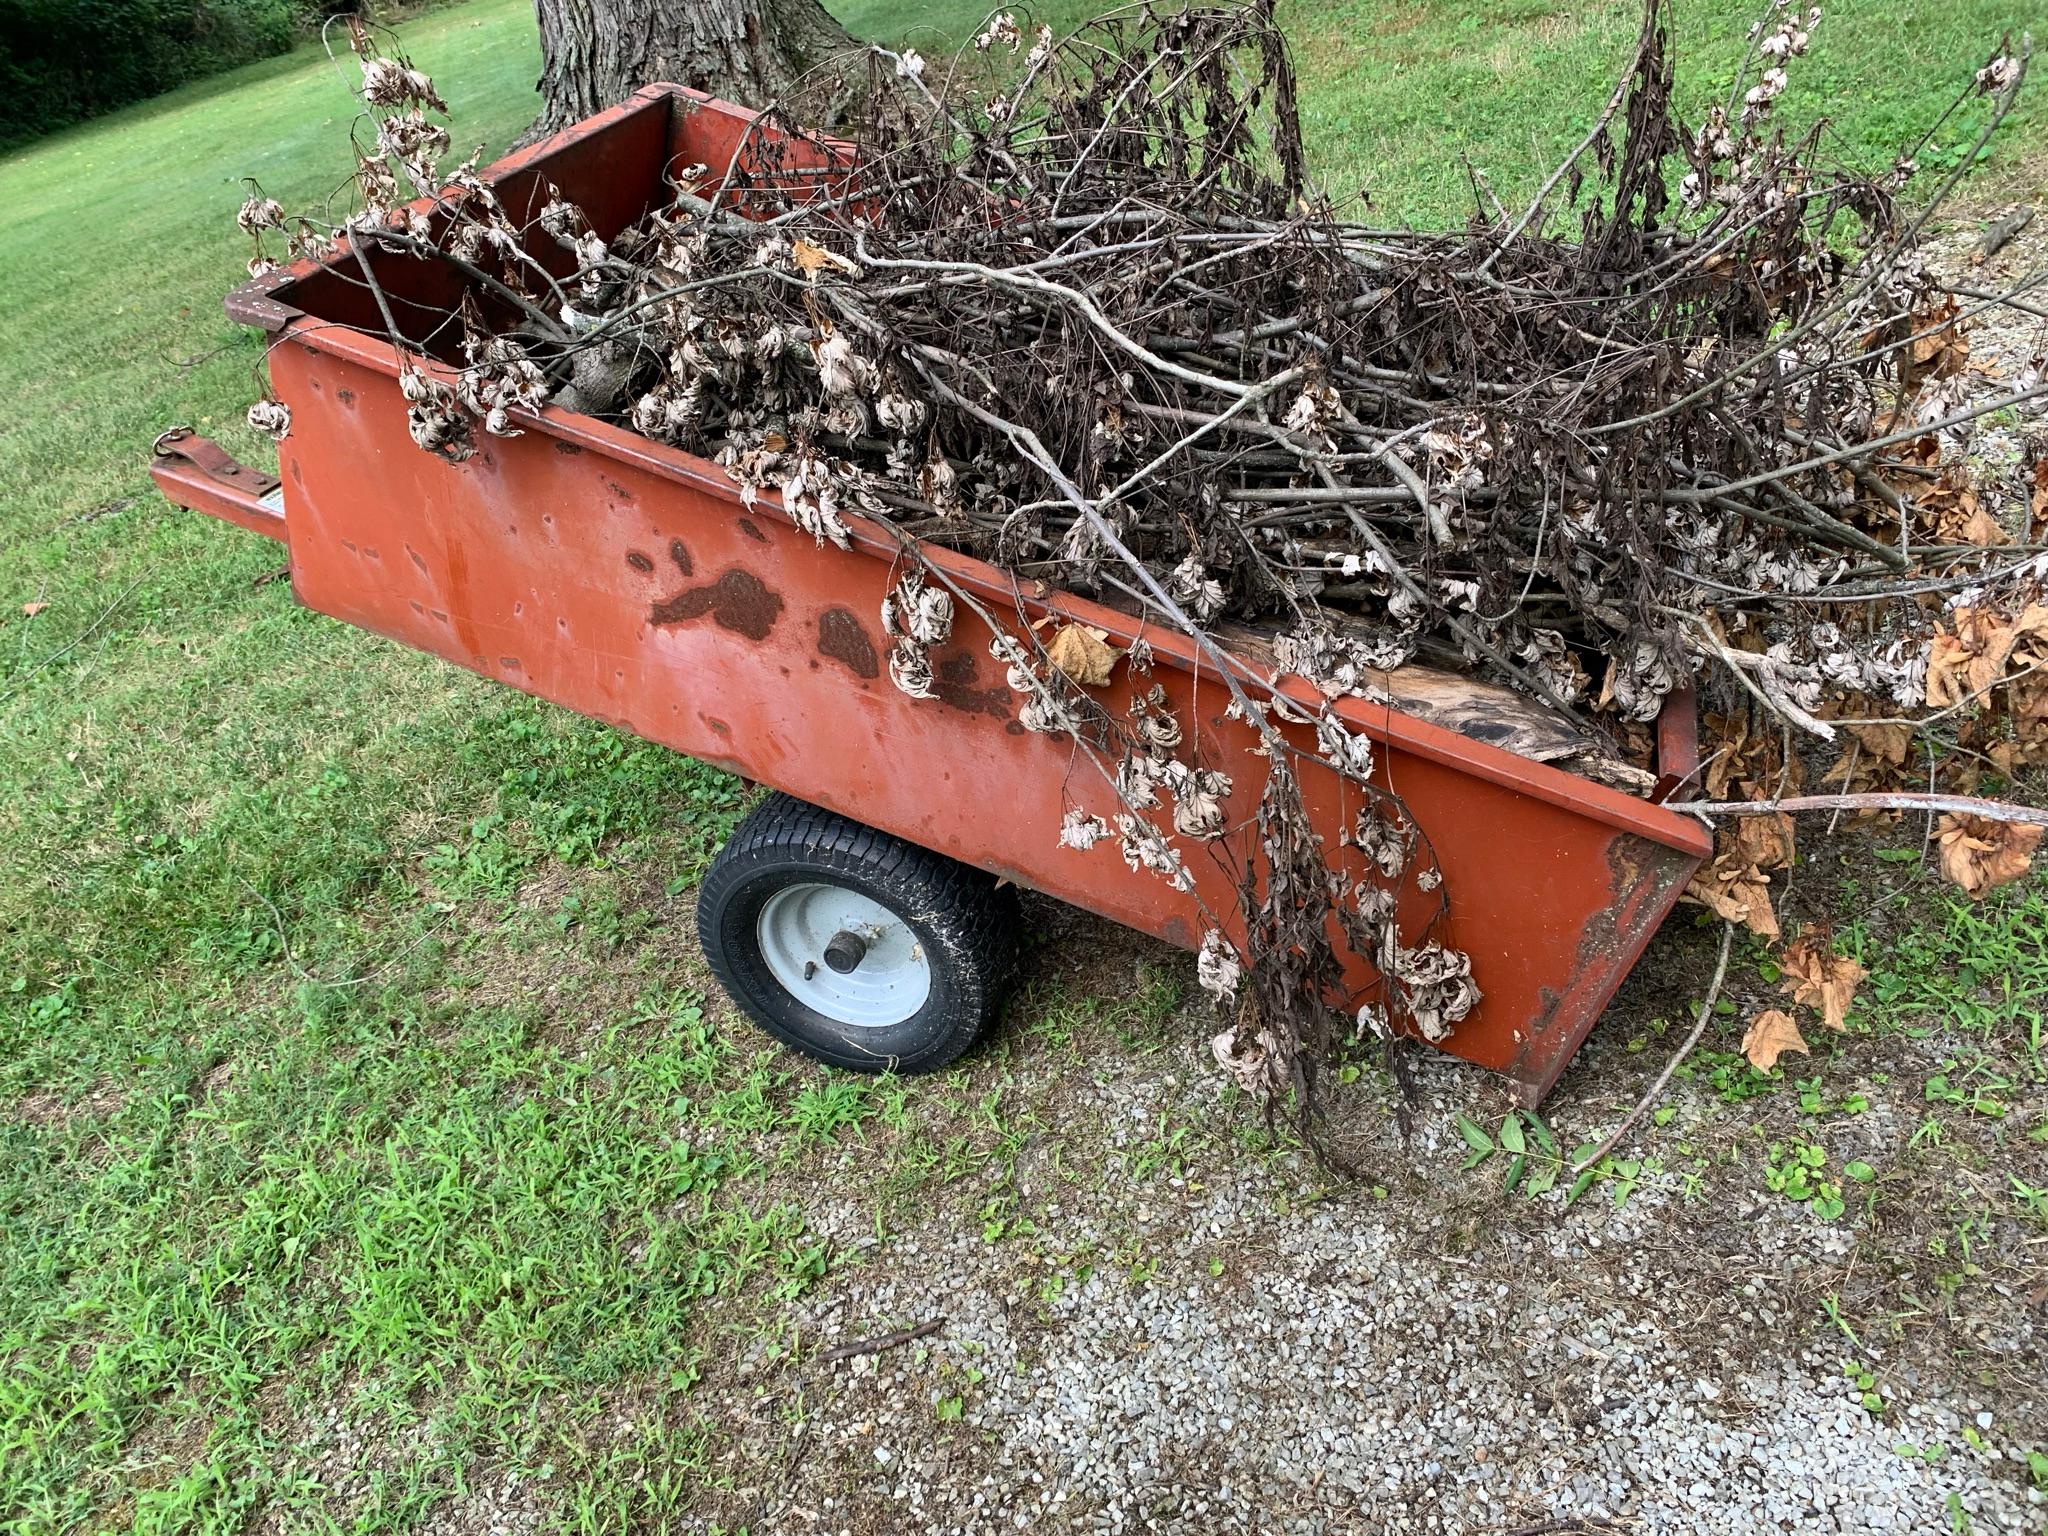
left=535, top=0, right=854, bottom=135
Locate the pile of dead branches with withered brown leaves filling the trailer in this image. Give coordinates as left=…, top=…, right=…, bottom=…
left=244, top=0, right=2048, bottom=1146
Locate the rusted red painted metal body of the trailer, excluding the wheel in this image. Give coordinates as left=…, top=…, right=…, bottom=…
left=156, top=86, right=1710, bottom=1100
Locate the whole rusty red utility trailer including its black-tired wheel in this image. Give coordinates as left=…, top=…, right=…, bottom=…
left=152, top=86, right=1712, bottom=1104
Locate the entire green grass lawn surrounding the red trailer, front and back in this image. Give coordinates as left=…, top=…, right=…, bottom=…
left=0, top=0, right=2044, bottom=1536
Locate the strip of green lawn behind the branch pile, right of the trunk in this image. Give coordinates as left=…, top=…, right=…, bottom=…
left=834, top=0, right=2044, bottom=223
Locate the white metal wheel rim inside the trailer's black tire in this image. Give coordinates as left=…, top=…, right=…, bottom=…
left=754, top=883, right=932, bottom=1030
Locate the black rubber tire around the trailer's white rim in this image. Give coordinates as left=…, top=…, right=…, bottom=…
left=696, top=795, right=1018, bottom=1073
